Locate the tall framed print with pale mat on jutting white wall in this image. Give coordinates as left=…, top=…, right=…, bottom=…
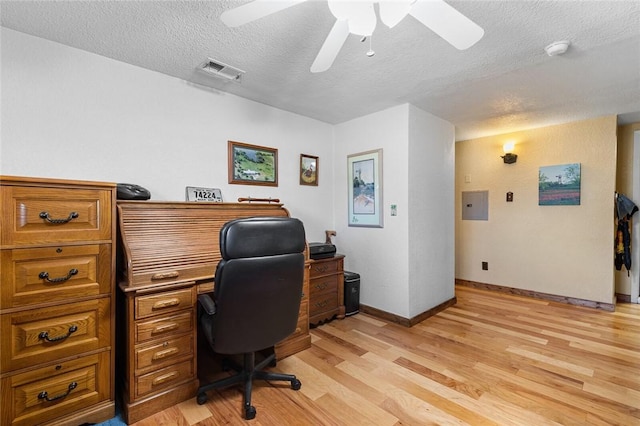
left=347, top=149, right=383, bottom=228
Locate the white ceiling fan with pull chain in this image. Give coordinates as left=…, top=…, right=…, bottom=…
left=220, top=0, right=484, bottom=73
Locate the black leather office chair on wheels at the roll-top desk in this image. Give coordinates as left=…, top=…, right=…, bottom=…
left=197, top=217, right=305, bottom=420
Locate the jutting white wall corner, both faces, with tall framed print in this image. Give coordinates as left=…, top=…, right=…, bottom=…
left=335, top=104, right=454, bottom=318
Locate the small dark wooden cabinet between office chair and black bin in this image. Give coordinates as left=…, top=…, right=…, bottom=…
left=309, top=254, right=345, bottom=325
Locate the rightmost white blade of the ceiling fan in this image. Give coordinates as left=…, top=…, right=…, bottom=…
left=409, top=0, right=484, bottom=50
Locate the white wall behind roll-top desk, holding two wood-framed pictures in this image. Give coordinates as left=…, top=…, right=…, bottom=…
left=0, top=28, right=334, bottom=241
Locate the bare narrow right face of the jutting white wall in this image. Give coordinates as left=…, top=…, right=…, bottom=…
left=404, top=106, right=455, bottom=317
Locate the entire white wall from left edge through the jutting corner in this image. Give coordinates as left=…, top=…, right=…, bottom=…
left=0, top=28, right=460, bottom=317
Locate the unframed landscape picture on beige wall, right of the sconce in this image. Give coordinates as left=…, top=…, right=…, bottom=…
left=538, top=163, right=581, bottom=206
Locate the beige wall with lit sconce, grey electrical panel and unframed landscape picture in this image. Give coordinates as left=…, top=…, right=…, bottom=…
left=456, top=116, right=616, bottom=303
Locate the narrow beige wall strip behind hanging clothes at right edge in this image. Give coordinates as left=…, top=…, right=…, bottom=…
left=615, top=123, right=640, bottom=295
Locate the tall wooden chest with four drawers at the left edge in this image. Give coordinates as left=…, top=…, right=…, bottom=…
left=0, top=176, right=115, bottom=425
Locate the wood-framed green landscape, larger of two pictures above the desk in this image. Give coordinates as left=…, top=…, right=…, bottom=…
left=227, top=141, right=278, bottom=186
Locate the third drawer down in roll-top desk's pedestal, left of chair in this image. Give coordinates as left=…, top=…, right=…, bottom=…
left=135, top=333, right=194, bottom=374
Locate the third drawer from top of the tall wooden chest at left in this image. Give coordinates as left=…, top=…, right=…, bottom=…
left=0, top=298, right=111, bottom=372
